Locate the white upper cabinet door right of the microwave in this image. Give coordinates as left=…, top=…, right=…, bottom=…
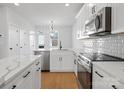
left=112, top=3, right=124, bottom=34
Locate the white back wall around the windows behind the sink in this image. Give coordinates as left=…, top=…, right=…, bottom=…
left=35, top=25, right=72, bottom=49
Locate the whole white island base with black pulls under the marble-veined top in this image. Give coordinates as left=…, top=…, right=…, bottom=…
left=3, top=59, right=41, bottom=89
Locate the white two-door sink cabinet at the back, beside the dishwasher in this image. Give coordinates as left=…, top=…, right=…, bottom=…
left=50, top=50, right=74, bottom=72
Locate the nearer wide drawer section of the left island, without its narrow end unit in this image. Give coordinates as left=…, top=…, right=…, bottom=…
left=3, top=66, right=33, bottom=89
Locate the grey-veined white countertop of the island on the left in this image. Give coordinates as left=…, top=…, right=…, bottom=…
left=0, top=55, right=41, bottom=84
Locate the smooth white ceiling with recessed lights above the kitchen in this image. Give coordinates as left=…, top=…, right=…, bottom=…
left=7, top=3, right=83, bottom=25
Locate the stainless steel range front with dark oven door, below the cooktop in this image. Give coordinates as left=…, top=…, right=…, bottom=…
left=77, top=53, right=92, bottom=89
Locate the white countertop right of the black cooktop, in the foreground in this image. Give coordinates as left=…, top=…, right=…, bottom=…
left=93, top=62, right=124, bottom=83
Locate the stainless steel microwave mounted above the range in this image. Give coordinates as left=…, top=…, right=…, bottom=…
left=85, top=7, right=111, bottom=36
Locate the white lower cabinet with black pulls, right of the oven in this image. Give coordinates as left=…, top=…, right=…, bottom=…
left=92, top=65, right=124, bottom=89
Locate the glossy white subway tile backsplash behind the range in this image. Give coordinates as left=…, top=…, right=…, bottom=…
left=82, top=35, right=124, bottom=58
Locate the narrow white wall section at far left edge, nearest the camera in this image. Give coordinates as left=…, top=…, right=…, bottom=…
left=0, top=6, right=8, bottom=58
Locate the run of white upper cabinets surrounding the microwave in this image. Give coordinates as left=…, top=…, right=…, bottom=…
left=75, top=3, right=124, bottom=39
